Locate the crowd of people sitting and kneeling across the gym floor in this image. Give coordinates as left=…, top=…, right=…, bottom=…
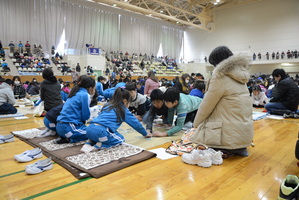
left=0, top=46, right=299, bottom=167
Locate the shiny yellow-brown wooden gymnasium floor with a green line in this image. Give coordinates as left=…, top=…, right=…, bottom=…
left=0, top=112, right=299, bottom=200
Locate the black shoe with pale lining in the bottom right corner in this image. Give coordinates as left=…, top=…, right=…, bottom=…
left=277, top=175, right=299, bottom=200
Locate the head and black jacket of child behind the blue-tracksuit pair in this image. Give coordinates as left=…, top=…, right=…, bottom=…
left=40, top=68, right=63, bottom=111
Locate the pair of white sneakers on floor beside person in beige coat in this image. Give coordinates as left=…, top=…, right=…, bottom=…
left=182, top=148, right=223, bottom=167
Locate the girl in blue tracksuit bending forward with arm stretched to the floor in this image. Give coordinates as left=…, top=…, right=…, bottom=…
left=81, top=88, right=151, bottom=153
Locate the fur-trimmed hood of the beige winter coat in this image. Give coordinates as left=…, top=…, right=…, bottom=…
left=213, top=55, right=250, bottom=83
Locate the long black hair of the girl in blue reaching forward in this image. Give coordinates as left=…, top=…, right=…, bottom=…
left=103, top=87, right=132, bottom=122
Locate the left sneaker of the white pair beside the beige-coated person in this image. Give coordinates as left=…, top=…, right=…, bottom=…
left=182, top=150, right=212, bottom=167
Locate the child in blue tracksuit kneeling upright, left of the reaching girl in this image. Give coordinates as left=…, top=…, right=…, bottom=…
left=56, top=75, right=95, bottom=144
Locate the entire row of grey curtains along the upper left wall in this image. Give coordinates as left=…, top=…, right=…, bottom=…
left=0, top=0, right=183, bottom=58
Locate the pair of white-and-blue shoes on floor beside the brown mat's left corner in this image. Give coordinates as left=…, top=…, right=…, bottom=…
left=14, top=148, right=53, bottom=174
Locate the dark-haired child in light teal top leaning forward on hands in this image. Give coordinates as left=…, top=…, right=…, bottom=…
left=153, top=87, right=202, bottom=137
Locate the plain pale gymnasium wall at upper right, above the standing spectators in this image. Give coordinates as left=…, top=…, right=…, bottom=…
left=184, top=0, right=299, bottom=62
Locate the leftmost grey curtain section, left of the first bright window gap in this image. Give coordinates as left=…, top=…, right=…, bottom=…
left=0, top=0, right=64, bottom=52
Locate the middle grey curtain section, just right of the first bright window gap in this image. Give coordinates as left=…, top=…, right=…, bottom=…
left=65, top=4, right=119, bottom=50
